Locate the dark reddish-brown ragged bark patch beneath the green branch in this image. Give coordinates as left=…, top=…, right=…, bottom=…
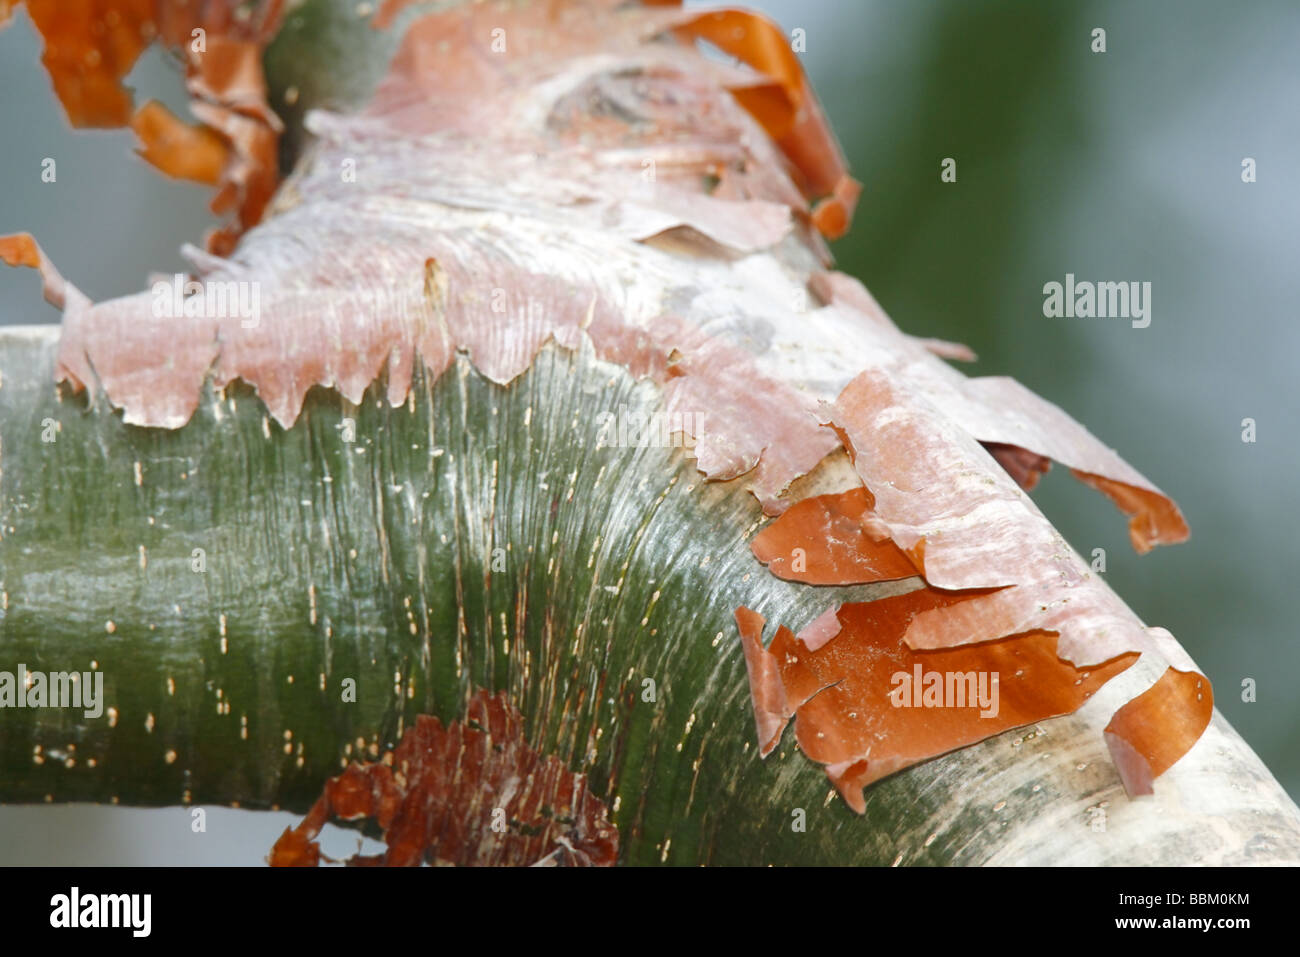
left=270, top=690, right=619, bottom=867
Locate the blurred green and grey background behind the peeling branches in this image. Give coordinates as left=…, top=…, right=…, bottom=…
left=0, top=0, right=1300, bottom=863
